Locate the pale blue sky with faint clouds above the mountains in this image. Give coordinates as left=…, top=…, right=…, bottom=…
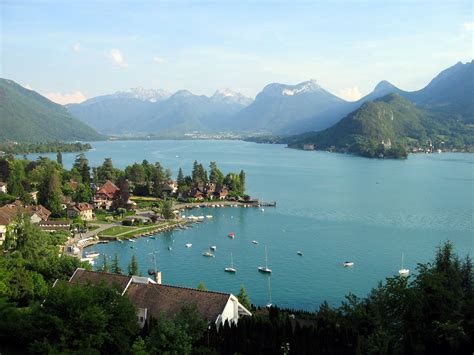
left=0, top=0, right=474, bottom=104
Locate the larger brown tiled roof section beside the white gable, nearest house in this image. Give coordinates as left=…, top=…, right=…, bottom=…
left=127, top=283, right=230, bottom=322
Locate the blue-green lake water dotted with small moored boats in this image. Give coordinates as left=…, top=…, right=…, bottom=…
left=26, top=141, right=474, bottom=310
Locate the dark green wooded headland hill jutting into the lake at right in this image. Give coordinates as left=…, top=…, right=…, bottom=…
left=287, top=94, right=474, bottom=157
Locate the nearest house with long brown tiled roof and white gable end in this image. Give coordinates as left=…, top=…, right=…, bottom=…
left=69, top=269, right=252, bottom=327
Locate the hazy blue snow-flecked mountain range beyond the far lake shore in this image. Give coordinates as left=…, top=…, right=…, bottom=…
left=68, top=61, right=474, bottom=136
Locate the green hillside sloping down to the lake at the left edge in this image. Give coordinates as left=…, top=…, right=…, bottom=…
left=0, top=79, right=103, bottom=143
